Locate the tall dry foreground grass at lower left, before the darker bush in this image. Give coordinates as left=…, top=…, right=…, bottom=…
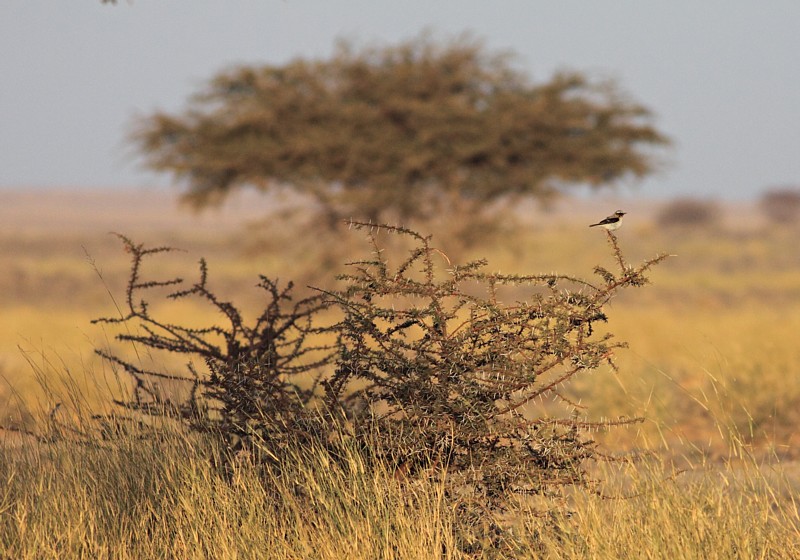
left=0, top=426, right=460, bottom=560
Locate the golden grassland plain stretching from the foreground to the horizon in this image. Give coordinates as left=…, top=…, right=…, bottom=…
left=0, top=193, right=800, bottom=558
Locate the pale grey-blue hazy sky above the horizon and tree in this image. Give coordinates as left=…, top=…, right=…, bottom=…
left=0, top=0, right=800, bottom=199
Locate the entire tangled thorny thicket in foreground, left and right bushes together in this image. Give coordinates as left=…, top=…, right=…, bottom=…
left=98, top=222, right=666, bottom=550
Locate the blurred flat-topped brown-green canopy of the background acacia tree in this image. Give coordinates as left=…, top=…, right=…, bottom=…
left=132, top=35, right=667, bottom=234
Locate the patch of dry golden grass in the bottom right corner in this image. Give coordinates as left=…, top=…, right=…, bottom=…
left=542, top=461, right=800, bottom=560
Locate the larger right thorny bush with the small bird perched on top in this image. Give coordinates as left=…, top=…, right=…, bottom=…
left=325, top=223, right=666, bottom=508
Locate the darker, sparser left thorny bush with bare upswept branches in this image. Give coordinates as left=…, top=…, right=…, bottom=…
left=93, top=235, right=337, bottom=450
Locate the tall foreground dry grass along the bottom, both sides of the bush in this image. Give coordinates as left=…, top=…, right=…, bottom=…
left=0, top=418, right=800, bottom=560
